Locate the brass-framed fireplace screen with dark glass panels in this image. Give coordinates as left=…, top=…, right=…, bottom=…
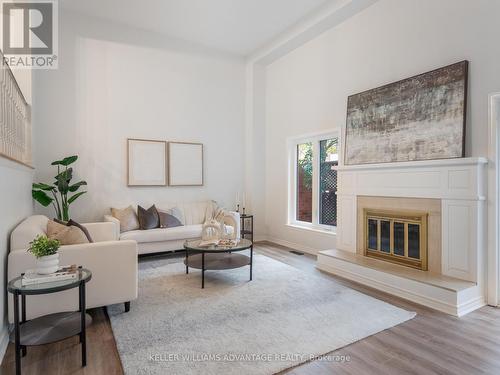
left=364, top=210, right=427, bottom=271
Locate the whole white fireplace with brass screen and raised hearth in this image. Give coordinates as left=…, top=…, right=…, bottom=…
left=318, top=158, right=488, bottom=316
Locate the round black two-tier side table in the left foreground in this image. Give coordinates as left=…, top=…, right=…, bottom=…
left=7, top=267, right=92, bottom=375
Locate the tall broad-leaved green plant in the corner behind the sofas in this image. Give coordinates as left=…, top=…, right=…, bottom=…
left=32, top=155, right=87, bottom=222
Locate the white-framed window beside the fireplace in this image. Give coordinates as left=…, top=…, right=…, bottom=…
left=289, top=133, right=339, bottom=230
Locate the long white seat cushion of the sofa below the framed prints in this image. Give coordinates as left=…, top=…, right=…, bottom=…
left=120, top=224, right=202, bottom=243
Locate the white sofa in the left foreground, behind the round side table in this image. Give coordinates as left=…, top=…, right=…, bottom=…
left=7, top=215, right=138, bottom=323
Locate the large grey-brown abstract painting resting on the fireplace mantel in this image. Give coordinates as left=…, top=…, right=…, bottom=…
left=344, top=61, right=468, bottom=165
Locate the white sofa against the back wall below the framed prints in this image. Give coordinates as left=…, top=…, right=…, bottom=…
left=104, top=201, right=240, bottom=254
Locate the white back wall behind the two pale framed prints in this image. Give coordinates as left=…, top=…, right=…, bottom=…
left=33, top=12, right=245, bottom=221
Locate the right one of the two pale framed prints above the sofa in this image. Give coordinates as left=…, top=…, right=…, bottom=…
left=168, top=142, right=203, bottom=186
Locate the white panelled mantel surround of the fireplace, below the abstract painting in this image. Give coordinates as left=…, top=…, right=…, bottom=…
left=318, top=157, right=488, bottom=311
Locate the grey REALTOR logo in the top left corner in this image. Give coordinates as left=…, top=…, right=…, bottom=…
left=2, top=0, right=57, bottom=69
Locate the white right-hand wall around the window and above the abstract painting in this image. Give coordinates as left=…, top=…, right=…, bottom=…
left=260, top=0, right=500, bottom=254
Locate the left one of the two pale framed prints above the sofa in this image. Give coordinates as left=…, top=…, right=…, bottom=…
left=127, top=138, right=167, bottom=186
